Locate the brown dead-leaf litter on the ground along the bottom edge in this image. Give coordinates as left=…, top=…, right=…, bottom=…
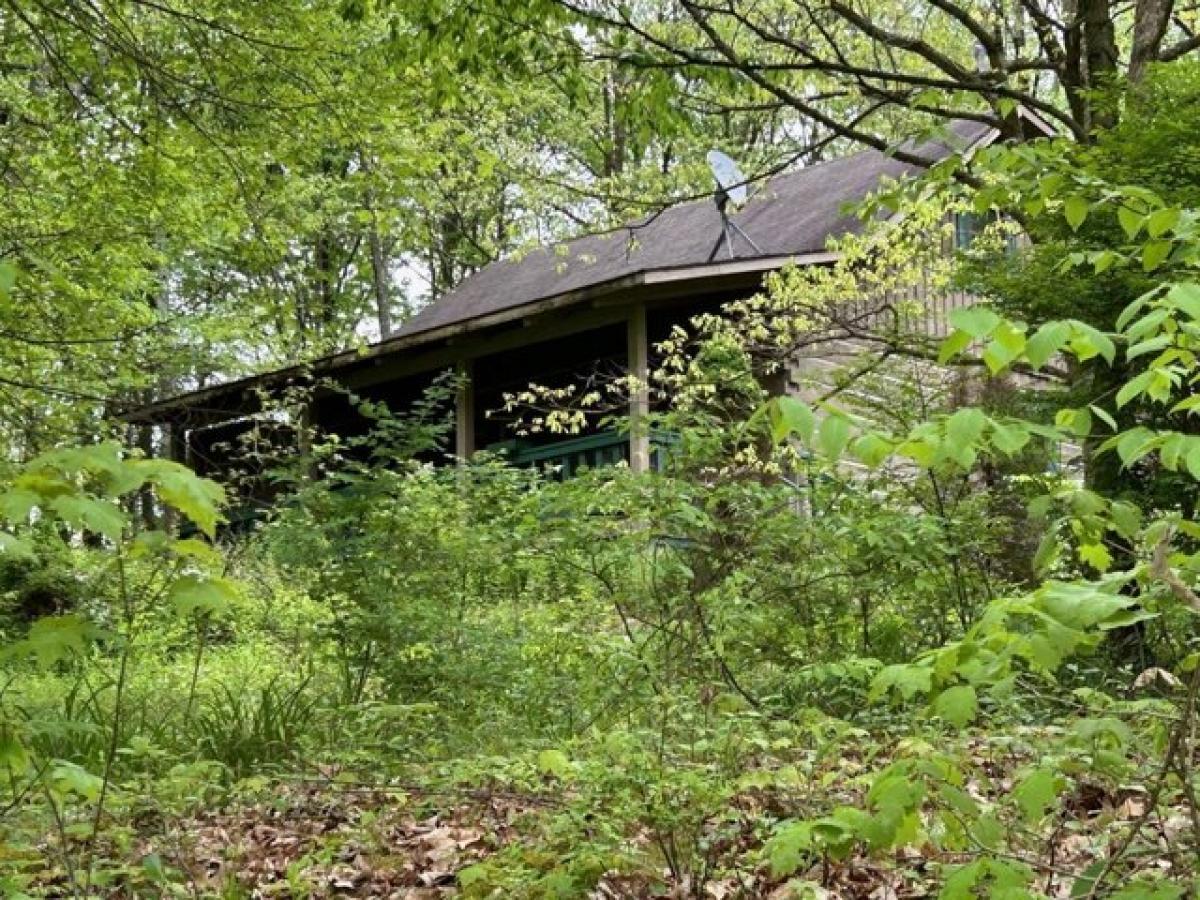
left=32, top=753, right=1187, bottom=900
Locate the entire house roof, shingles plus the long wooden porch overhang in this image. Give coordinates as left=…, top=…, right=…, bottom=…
left=121, top=121, right=1051, bottom=426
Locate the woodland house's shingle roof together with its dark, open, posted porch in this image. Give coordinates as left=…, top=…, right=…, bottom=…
left=124, top=120, right=1044, bottom=496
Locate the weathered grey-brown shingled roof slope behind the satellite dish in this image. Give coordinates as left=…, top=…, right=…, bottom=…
left=394, top=121, right=989, bottom=337
